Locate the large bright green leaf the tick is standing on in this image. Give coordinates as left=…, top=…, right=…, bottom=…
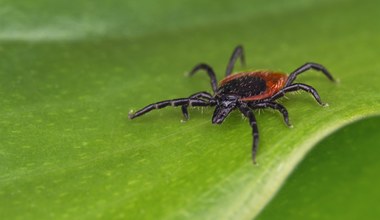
left=0, top=0, right=380, bottom=219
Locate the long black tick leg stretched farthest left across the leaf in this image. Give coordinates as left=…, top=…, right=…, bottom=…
left=128, top=98, right=210, bottom=119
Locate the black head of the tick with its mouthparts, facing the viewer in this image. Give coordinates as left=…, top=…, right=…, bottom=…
left=212, top=96, right=238, bottom=124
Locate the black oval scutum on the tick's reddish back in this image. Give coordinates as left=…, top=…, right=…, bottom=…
left=218, top=76, right=266, bottom=97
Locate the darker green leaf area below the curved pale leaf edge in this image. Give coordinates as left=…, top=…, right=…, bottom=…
left=257, top=117, right=380, bottom=219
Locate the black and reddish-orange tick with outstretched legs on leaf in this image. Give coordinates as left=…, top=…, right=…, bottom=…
left=129, top=45, right=335, bottom=163
